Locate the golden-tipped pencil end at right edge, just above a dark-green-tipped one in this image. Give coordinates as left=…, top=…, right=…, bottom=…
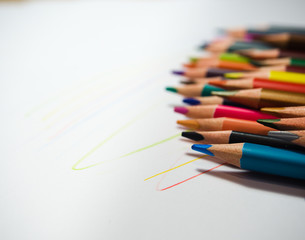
left=260, top=106, right=305, bottom=118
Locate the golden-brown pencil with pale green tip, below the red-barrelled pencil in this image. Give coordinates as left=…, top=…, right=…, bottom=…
left=212, top=88, right=305, bottom=108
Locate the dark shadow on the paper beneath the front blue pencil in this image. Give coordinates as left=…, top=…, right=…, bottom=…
left=198, top=169, right=305, bottom=198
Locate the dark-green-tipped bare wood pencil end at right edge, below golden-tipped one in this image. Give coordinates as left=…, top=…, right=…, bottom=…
left=257, top=117, right=305, bottom=130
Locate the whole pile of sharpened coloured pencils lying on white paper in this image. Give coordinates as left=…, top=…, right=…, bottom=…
left=166, top=26, right=305, bottom=180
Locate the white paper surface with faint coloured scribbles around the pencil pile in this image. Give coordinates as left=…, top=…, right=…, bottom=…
left=0, top=0, right=305, bottom=240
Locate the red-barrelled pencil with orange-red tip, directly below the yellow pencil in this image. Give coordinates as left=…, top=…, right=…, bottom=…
left=210, top=78, right=305, bottom=93
